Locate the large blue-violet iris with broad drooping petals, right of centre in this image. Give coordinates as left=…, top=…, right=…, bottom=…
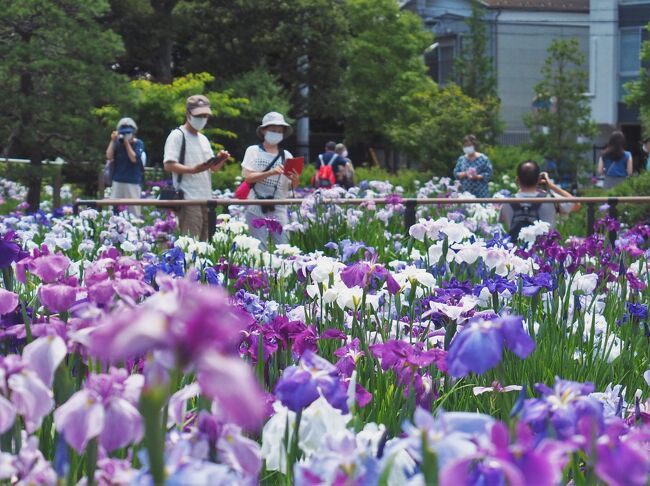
left=447, top=316, right=535, bottom=378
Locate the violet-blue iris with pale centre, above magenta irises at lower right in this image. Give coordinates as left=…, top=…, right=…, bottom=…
left=521, top=377, right=604, bottom=440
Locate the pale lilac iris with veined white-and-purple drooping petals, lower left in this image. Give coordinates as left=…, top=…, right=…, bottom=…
left=54, top=368, right=144, bottom=453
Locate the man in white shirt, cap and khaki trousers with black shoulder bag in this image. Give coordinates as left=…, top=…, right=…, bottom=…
left=164, top=95, right=230, bottom=241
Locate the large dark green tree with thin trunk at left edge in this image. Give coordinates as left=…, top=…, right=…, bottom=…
left=0, top=0, right=126, bottom=210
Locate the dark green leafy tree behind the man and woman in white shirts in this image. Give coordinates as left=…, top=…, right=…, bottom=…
left=172, top=0, right=347, bottom=117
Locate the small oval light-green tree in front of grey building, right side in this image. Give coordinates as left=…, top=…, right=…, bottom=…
left=524, top=39, right=596, bottom=178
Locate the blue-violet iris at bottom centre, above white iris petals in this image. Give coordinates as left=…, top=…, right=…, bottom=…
left=275, top=350, right=348, bottom=413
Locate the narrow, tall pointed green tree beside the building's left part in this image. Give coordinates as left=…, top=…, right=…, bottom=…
left=454, top=0, right=503, bottom=141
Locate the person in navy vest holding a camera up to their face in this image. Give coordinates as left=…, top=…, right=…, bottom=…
left=106, top=117, right=147, bottom=217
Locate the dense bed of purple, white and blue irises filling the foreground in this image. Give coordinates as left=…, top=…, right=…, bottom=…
left=0, top=180, right=650, bottom=485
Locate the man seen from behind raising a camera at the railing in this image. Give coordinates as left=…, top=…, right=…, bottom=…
left=499, top=160, right=580, bottom=241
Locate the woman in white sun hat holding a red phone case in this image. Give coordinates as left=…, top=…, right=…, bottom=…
left=242, top=112, right=300, bottom=250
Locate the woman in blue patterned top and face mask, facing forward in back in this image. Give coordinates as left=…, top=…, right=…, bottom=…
left=454, top=135, right=492, bottom=197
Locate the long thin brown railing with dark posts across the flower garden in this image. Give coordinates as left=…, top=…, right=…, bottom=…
left=73, top=196, right=650, bottom=244
